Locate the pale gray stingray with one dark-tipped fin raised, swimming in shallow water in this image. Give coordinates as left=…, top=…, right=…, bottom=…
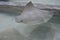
left=16, top=2, right=53, bottom=25
